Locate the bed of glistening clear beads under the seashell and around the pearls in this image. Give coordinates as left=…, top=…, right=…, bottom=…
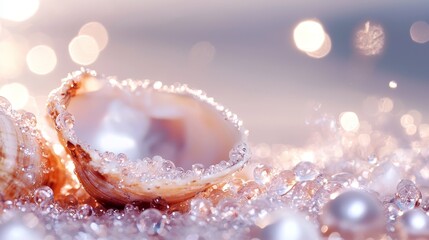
left=0, top=135, right=429, bottom=239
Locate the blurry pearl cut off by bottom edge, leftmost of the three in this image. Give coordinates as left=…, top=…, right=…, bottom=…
left=259, top=211, right=321, bottom=240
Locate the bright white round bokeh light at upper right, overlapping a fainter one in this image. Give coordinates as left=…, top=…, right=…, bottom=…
left=293, top=20, right=326, bottom=52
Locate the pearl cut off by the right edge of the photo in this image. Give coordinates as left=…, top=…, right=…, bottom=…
left=398, top=209, right=429, bottom=239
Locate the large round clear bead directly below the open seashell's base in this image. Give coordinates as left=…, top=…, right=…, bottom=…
left=137, top=208, right=164, bottom=236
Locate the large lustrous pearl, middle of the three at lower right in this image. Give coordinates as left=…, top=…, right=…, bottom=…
left=320, top=190, right=383, bottom=238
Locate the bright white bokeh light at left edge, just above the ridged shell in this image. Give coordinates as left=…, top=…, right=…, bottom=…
left=0, top=82, right=29, bottom=109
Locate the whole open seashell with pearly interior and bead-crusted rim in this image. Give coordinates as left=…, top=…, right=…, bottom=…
left=48, top=70, right=250, bottom=206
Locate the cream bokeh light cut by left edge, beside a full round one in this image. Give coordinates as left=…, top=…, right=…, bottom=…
left=0, top=40, right=24, bottom=78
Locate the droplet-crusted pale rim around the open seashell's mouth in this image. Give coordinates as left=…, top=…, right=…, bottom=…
left=47, top=68, right=251, bottom=186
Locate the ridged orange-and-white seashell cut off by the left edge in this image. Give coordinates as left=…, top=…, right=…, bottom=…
left=0, top=97, right=64, bottom=199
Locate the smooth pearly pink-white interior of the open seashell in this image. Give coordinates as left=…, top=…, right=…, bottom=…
left=67, top=79, right=241, bottom=170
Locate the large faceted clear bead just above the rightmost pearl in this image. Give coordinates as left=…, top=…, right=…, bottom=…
left=395, top=179, right=422, bottom=211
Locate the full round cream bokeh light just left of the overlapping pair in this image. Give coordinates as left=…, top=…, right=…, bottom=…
left=27, top=45, right=57, bottom=75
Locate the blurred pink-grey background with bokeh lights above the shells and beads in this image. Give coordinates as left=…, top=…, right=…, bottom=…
left=0, top=0, right=429, bottom=145
